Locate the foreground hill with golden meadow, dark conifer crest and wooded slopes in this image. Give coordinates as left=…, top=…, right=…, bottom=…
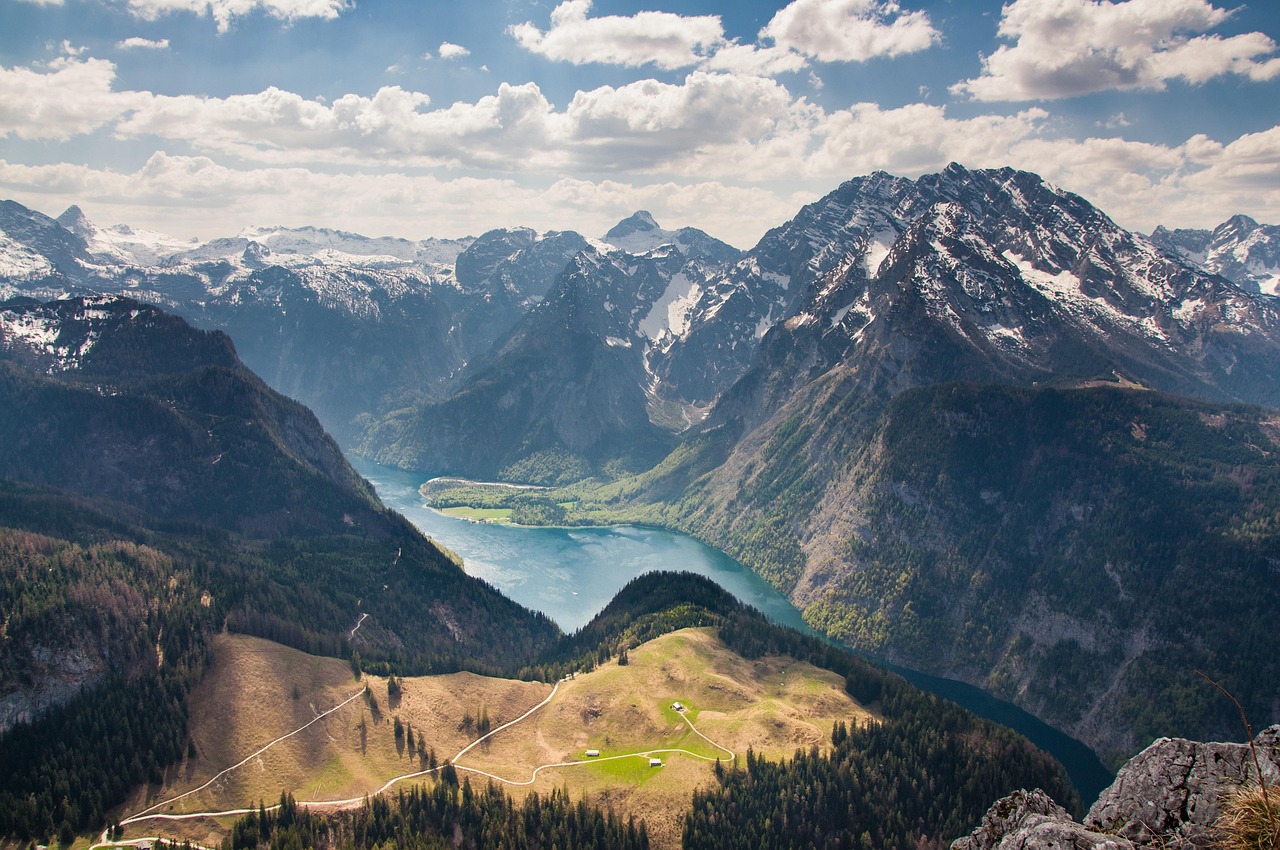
left=102, top=563, right=1079, bottom=850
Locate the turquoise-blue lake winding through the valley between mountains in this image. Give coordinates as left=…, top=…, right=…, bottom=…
left=352, top=460, right=1112, bottom=806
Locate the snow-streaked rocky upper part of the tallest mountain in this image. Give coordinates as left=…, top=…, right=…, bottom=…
left=717, top=165, right=1280, bottom=435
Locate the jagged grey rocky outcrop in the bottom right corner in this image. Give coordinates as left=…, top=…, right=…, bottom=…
left=951, top=725, right=1280, bottom=850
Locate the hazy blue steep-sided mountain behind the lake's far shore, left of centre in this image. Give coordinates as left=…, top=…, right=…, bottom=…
left=357, top=246, right=687, bottom=483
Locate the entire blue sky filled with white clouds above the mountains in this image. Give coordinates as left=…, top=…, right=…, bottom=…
left=0, top=0, right=1280, bottom=248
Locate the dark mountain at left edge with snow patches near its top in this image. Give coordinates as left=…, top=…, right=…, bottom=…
left=0, top=296, right=388, bottom=536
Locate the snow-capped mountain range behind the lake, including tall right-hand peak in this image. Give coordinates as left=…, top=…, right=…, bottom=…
left=0, top=164, right=1280, bottom=760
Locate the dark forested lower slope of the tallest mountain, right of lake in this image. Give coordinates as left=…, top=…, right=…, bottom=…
left=666, top=381, right=1280, bottom=758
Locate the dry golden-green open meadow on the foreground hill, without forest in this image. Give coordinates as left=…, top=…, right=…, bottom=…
left=115, top=629, right=874, bottom=846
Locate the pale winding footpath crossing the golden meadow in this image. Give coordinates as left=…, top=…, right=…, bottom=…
left=90, top=675, right=737, bottom=850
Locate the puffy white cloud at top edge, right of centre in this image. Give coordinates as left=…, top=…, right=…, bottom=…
left=760, top=0, right=941, bottom=61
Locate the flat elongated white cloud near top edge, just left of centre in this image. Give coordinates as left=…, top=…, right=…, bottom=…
left=508, top=0, right=724, bottom=70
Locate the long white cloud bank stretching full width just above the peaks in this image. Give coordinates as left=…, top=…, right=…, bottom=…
left=10, top=50, right=1280, bottom=245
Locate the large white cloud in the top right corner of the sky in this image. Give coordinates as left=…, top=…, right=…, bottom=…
left=951, top=0, right=1280, bottom=100
